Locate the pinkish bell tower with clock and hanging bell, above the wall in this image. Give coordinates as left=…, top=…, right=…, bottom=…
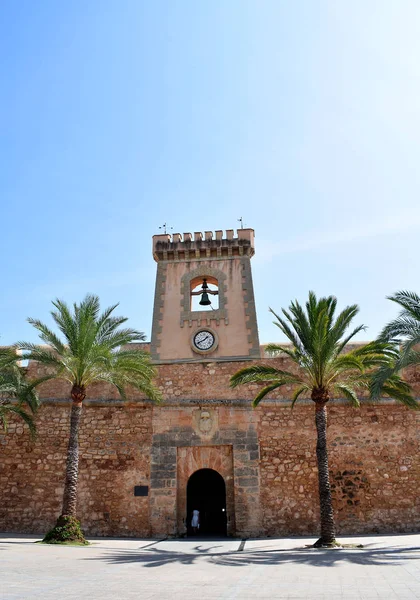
left=151, top=229, right=260, bottom=363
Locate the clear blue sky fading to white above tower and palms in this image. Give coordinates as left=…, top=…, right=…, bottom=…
left=0, top=0, right=420, bottom=344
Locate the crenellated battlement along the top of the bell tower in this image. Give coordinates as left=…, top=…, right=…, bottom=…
left=153, top=229, right=255, bottom=262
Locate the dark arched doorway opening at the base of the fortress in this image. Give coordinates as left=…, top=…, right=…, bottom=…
left=187, top=469, right=226, bottom=536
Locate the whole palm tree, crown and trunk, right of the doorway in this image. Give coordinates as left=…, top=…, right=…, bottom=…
left=230, top=292, right=417, bottom=547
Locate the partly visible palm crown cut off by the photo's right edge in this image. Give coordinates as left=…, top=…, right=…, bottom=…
left=372, top=291, right=420, bottom=398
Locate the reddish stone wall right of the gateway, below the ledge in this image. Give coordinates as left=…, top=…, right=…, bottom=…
left=259, top=403, right=420, bottom=535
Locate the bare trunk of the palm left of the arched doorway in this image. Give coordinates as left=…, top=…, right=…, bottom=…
left=62, top=402, right=82, bottom=517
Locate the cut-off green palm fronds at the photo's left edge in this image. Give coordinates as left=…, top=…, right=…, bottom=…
left=0, top=348, right=39, bottom=438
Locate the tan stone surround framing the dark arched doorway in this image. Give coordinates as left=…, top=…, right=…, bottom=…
left=177, top=445, right=236, bottom=536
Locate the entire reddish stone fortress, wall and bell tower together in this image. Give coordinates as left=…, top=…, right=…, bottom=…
left=0, top=229, right=420, bottom=537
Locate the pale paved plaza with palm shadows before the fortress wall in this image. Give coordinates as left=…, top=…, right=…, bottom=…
left=0, top=534, right=420, bottom=600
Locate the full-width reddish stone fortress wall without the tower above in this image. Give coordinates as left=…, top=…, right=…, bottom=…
left=0, top=359, right=420, bottom=536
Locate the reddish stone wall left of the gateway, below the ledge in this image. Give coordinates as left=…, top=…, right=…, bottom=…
left=0, top=404, right=152, bottom=536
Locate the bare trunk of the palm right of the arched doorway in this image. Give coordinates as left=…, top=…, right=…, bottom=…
left=314, top=403, right=335, bottom=547
